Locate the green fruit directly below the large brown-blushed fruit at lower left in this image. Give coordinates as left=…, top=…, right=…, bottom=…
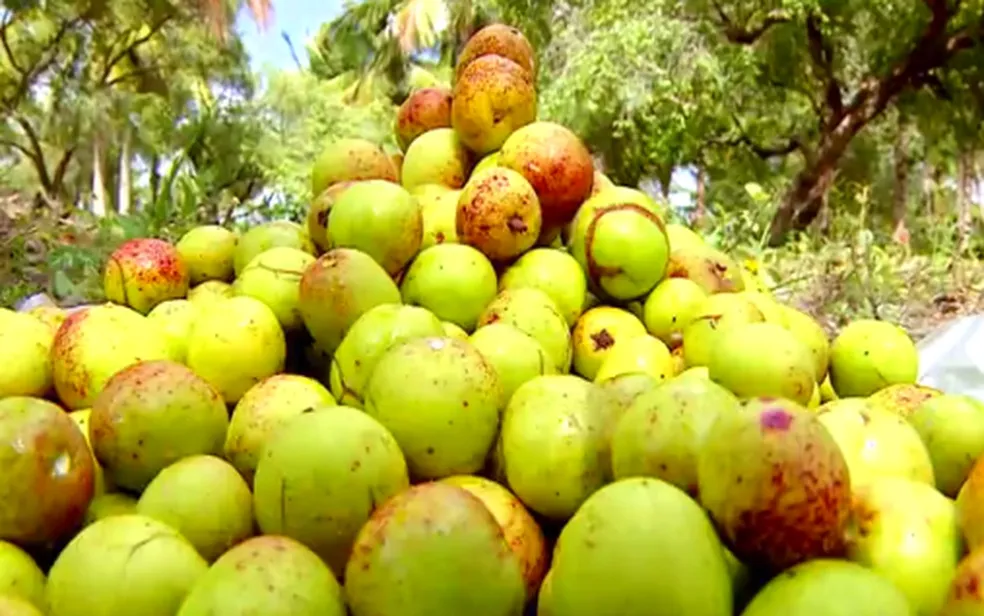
left=137, top=455, right=253, bottom=562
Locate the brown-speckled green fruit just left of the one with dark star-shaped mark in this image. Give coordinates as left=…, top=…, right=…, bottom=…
left=478, top=288, right=571, bottom=373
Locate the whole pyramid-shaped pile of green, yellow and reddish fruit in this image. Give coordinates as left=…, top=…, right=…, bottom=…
left=0, top=25, right=984, bottom=616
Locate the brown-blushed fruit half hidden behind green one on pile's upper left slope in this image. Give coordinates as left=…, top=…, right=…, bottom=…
left=311, top=138, right=398, bottom=195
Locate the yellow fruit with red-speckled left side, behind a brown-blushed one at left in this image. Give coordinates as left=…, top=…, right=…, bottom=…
left=51, top=304, right=173, bottom=411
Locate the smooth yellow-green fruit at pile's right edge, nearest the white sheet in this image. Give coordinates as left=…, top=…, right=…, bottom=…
left=830, top=319, right=919, bottom=398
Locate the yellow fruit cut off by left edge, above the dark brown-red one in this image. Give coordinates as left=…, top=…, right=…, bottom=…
left=0, top=312, right=54, bottom=398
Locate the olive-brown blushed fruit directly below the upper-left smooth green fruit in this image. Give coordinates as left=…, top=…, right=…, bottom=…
left=300, top=248, right=401, bottom=354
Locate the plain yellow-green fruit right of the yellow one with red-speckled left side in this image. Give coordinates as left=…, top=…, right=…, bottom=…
left=188, top=296, right=287, bottom=404
